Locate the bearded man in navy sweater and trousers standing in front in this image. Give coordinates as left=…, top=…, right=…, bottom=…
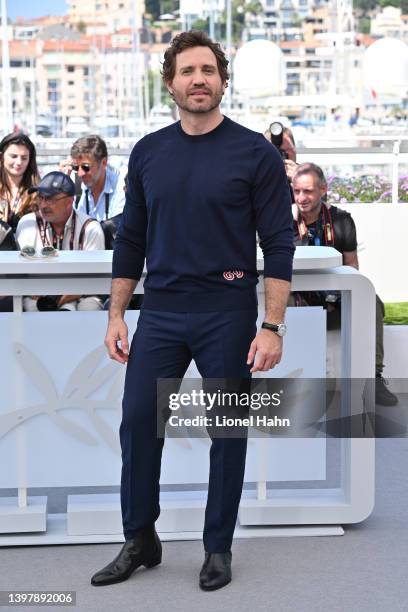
left=92, top=32, right=294, bottom=590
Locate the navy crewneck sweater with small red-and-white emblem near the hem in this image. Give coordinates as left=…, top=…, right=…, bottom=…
left=112, top=117, right=294, bottom=312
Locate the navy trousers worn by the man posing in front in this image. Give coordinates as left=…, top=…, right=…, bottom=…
left=120, top=309, right=257, bottom=552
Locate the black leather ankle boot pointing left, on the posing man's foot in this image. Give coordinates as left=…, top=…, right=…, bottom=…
left=91, top=527, right=162, bottom=586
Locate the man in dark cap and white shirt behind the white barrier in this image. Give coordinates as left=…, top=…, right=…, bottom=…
left=16, top=172, right=105, bottom=312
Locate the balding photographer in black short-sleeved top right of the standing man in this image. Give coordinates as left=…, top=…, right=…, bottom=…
left=290, top=163, right=398, bottom=406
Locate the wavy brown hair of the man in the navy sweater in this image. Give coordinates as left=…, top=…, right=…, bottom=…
left=162, top=30, right=230, bottom=83
